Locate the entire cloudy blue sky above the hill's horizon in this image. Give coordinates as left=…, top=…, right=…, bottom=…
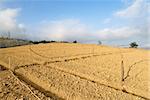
left=0, top=0, right=150, bottom=46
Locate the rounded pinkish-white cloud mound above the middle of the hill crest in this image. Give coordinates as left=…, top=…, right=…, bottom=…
left=37, top=19, right=92, bottom=41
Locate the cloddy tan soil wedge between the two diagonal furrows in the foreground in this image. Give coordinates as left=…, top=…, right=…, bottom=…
left=16, top=66, right=145, bottom=100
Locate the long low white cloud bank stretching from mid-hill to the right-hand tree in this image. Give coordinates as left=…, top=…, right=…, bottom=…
left=37, top=19, right=142, bottom=42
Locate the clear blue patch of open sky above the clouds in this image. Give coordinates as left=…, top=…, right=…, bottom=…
left=6, top=0, right=123, bottom=27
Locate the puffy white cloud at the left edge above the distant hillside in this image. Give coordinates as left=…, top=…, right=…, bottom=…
left=0, top=8, right=25, bottom=38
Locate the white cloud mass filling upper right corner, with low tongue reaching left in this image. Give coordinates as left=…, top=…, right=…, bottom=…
left=96, top=0, right=150, bottom=41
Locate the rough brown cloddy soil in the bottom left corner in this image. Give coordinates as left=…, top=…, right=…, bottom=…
left=0, top=71, right=37, bottom=100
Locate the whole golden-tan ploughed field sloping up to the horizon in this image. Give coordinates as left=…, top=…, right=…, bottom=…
left=0, top=43, right=150, bottom=100
